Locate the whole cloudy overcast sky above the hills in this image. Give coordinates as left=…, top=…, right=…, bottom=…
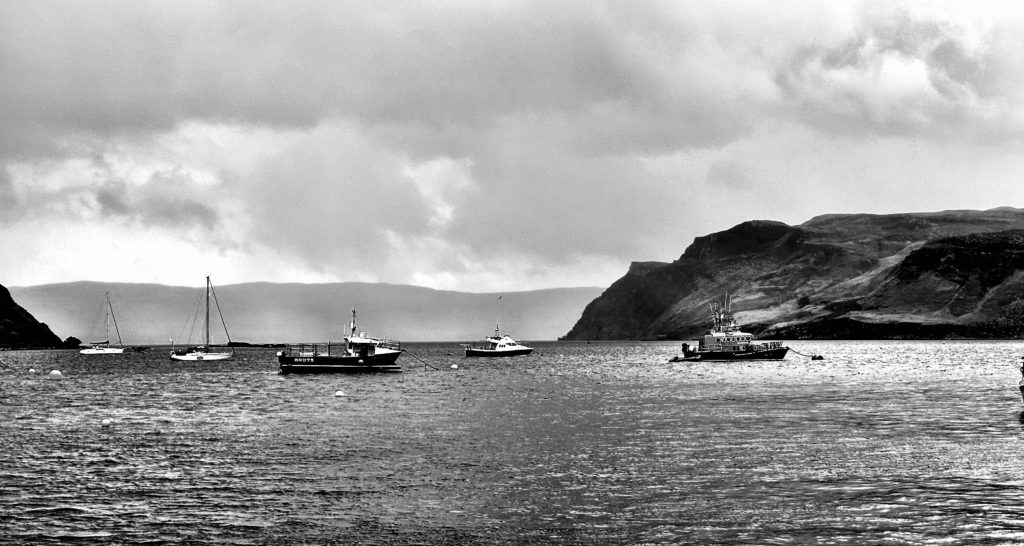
left=0, top=0, right=1024, bottom=292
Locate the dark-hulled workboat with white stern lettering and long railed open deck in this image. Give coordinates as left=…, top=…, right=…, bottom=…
left=278, top=307, right=402, bottom=374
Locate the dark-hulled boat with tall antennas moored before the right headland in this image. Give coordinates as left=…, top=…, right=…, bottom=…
left=670, top=298, right=790, bottom=362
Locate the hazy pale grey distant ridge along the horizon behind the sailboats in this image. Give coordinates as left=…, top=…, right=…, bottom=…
left=10, top=278, right=601, bottom=345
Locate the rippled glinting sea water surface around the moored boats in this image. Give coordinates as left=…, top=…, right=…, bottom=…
left=0, top=341, right=1024, bottom=544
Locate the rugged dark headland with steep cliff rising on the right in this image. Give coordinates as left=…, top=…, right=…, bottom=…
left=563, top=208, right=1024, bottom=339
